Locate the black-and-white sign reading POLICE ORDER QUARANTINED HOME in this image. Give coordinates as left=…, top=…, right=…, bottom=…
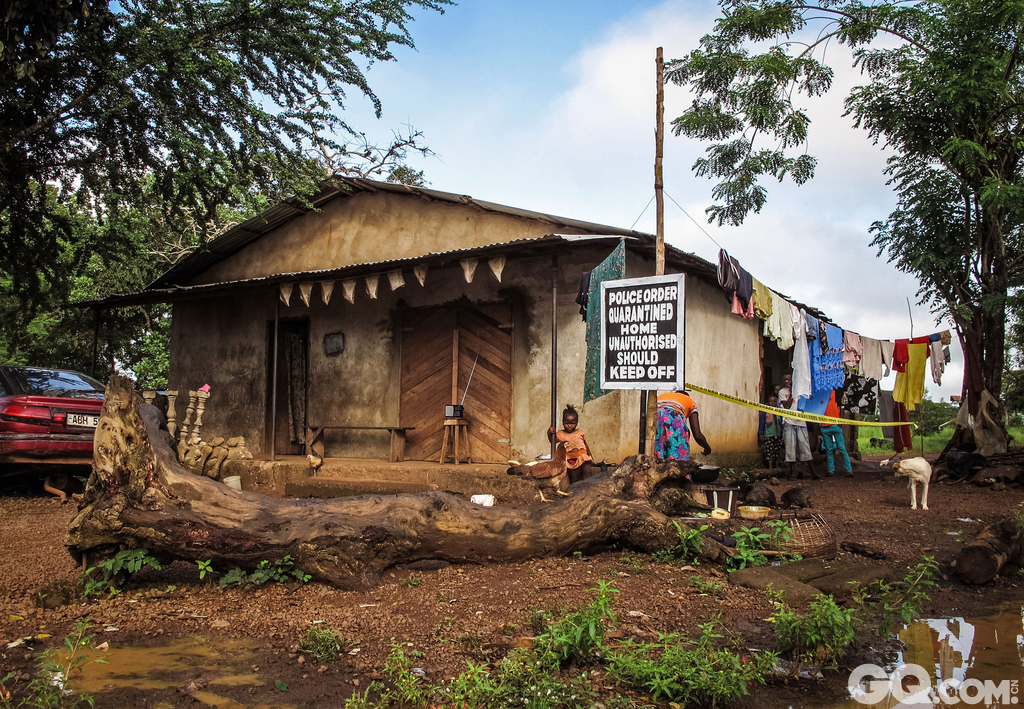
left=601, top=274, right=686, bottom=389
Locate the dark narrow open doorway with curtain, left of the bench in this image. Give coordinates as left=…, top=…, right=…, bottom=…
left=265, top=318, right=309, bottom=455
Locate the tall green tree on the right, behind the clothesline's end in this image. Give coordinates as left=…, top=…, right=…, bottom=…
left=668, top=0, right=1024, bottom=407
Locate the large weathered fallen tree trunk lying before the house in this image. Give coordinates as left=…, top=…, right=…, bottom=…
left=65, top=376, right=704, bottom=589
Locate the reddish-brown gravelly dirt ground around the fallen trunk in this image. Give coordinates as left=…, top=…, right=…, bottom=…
left=0, top=464, right=1024, bottom=709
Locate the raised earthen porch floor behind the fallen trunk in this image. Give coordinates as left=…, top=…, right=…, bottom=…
left=221, top=456, right=537, bottom=503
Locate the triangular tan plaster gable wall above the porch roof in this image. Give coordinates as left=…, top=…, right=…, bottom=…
left=194, top=193, right=578, bottom=284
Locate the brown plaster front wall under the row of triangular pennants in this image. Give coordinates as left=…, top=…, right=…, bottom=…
left=171, top=249, right=638, bottom=461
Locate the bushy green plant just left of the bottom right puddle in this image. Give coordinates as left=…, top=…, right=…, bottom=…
left=775, top=594, right=856, bottom=669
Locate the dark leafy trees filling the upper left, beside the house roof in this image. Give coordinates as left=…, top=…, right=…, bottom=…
left=0, top=0, right=450, bottom=381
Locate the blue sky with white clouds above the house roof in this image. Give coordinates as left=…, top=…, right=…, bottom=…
left=346, top=0, right=963, bottom=398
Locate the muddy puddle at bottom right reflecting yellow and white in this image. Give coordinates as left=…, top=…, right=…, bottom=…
left=830, top=603, right=1024, bottom=709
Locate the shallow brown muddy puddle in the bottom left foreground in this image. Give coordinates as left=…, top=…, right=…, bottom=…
left=61, top=636, right=289, bottom=709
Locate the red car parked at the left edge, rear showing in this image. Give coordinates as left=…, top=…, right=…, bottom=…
left=0, top=365, right=104, bottom=466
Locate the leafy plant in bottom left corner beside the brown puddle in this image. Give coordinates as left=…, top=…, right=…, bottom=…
left=0, top=621, right=106, bottom=709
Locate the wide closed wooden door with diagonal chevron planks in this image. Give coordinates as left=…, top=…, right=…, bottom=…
left=401, top=303, right=512, bottom=463
